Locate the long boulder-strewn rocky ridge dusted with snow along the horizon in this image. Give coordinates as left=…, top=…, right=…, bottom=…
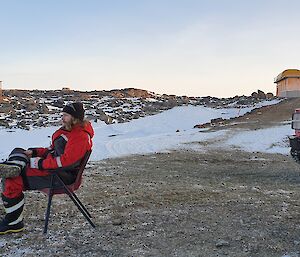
left=0, top=88, right=274, bottom=129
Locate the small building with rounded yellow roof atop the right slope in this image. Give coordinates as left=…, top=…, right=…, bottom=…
left=274, top=69, right=300, bottom=97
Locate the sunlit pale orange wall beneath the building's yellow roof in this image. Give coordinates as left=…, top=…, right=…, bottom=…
left=276, top=78, right=300, bottom=97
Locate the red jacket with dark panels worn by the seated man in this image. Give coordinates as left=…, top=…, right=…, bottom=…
left=32, top=122, right=94, bottom=170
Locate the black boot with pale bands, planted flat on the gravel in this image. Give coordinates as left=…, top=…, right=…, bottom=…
left=0, top=193, right=24, bottom=235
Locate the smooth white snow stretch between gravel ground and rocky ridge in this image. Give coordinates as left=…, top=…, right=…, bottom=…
left=0, top=100, right=293, bottom=161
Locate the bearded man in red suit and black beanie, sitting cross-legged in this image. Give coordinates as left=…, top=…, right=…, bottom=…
left=0, top=102, right=94, bottom=234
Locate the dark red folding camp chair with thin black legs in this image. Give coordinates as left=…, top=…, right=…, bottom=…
left=39, top=151, right=95, bottom=234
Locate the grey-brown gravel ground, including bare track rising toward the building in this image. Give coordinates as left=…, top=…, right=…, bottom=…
left=0, top=95, right=300, bottom=257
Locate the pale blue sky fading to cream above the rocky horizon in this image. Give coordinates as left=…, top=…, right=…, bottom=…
left=0, top=0, right=300, bottom=97
